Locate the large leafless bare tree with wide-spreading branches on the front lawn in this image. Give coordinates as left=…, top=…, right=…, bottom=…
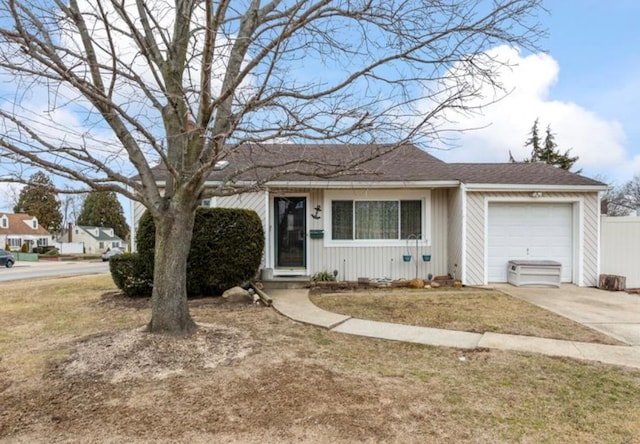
left=0, top=0, right=541, bottom=333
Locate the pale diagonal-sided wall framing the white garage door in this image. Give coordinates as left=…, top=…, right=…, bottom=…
left=464, top=191, right=600, bottom=286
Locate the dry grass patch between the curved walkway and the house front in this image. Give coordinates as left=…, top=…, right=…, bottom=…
left=311, top=289, right=621, bottom=345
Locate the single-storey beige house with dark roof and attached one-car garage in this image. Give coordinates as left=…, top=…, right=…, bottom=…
left=132, top=145, right=607, bottom=286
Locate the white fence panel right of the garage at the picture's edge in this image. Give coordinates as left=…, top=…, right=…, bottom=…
left=600, top=216, right=640, bottom=288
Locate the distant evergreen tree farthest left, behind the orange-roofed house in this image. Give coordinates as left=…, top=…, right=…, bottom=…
left=13, top=171, right=62, bottom=233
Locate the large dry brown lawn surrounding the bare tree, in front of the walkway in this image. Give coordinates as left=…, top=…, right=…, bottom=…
left=0, top=276, right=640, bottom=443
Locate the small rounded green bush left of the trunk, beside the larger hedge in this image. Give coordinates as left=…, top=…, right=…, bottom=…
left=109, top=253, right=153, bottom=297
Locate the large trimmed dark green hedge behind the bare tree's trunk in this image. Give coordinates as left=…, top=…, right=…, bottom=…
left=112, top=208, right=264, bottom=296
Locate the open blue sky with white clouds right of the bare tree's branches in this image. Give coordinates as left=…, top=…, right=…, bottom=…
left=433, top=0, right=640, bottom=185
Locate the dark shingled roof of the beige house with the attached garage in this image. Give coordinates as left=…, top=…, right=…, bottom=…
left=149, top=144, right=605, bottom=186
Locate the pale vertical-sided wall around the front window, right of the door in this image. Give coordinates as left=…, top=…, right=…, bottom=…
left=307, top=190, right=448, bottom=280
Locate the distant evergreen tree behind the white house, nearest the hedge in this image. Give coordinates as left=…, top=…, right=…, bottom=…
left=76, top=191, right=129, bottom=239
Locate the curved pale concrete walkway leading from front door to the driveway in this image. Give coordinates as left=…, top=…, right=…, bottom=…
left=269, top=289, right=640, bottom=369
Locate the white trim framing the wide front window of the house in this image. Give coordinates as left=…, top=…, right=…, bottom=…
left=323, top=189, right=431, bottom=247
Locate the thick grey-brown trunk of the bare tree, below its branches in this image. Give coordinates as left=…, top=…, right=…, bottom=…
left=149, top=204, right=196, bottom=335
